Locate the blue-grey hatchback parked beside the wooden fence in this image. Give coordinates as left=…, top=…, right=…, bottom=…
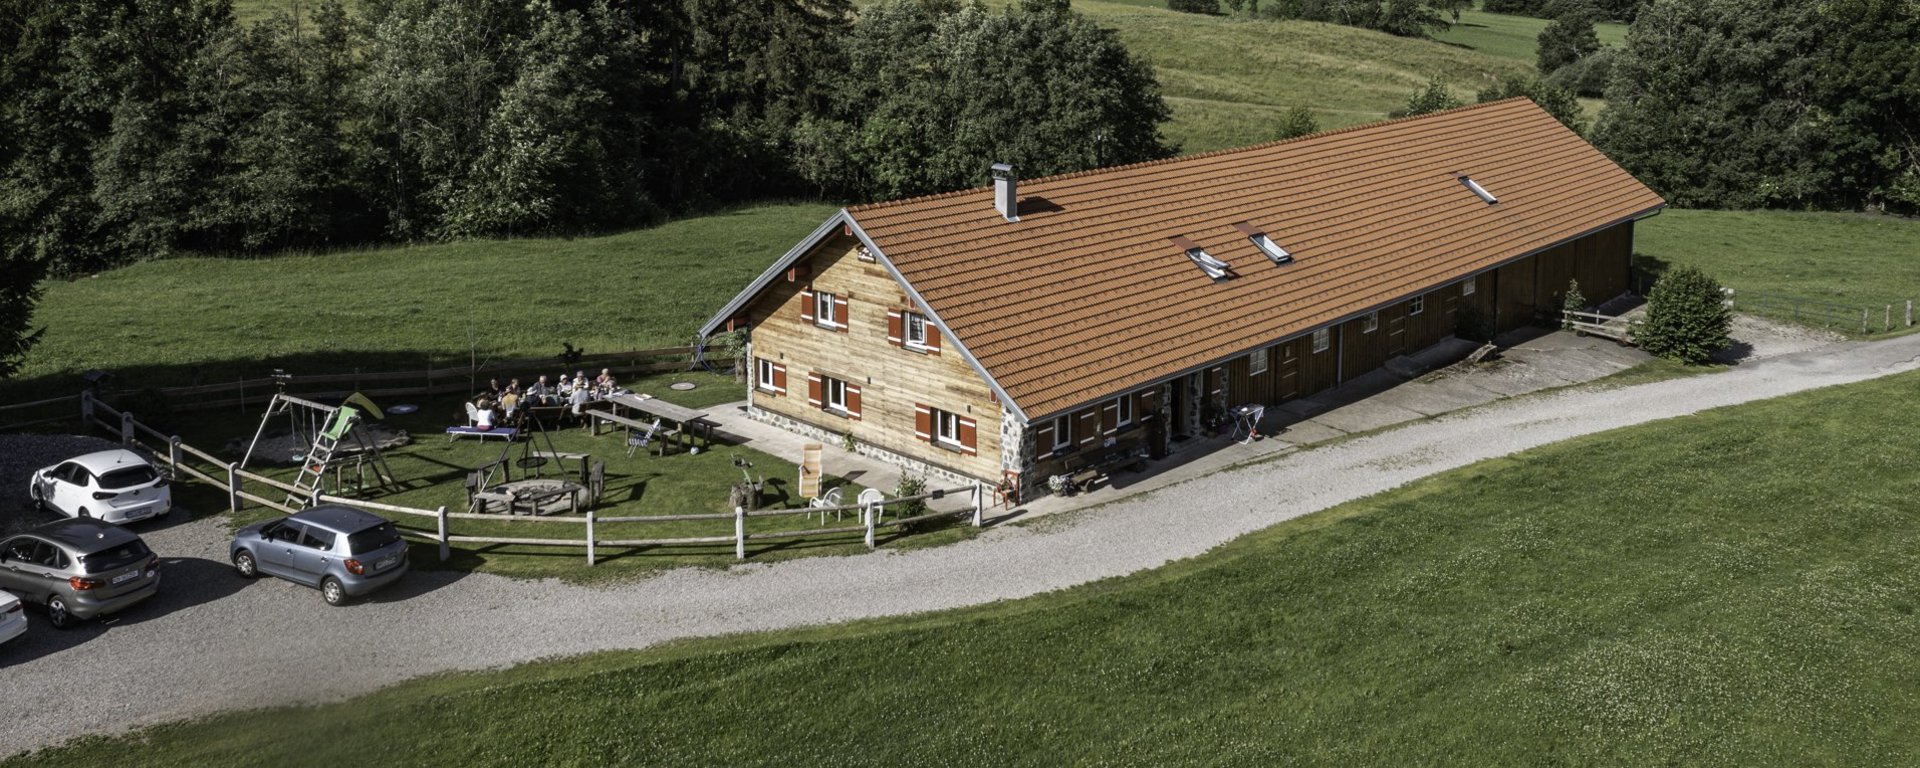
left=228, top=505, right=407, bottom=605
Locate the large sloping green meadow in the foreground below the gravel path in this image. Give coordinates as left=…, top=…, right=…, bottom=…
left=17, top=374, right=1920, bottom=766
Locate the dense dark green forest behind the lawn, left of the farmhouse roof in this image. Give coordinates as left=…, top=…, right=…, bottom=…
left=0, top=0, right=1173, bottom=275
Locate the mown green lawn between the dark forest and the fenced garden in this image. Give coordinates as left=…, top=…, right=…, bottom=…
left=0, top=204, right=833, bottom=401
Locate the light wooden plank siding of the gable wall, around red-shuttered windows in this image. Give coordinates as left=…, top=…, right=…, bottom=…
left=747, top=234, right=1000, bottom=482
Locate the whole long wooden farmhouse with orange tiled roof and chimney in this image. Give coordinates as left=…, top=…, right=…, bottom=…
left=703, top=98, right=1665, bottom=493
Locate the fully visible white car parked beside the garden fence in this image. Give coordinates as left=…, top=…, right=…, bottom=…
left=27, top=447, right=173, bottom=522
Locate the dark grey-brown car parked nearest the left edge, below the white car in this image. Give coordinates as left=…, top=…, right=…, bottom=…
left=0, top=518, right=159, bottom=630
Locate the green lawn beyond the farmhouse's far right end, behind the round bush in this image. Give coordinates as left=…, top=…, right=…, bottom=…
left=1634, top=211, right=1920, bottom=332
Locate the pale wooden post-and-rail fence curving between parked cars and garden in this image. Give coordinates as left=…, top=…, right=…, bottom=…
left=67, top=394, right=987, bottom=566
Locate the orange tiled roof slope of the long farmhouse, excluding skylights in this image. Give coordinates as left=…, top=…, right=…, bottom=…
left=849, top=98, right=1665, bottom=419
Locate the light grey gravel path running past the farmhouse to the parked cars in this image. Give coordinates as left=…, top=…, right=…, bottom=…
left=0, top=336, right=1920, bottom=755
